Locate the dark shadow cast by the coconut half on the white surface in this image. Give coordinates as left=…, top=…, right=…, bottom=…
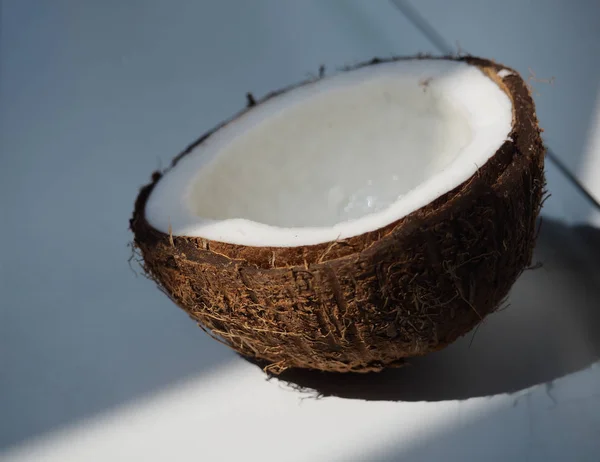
left=241, top=220, right=600, bottom=401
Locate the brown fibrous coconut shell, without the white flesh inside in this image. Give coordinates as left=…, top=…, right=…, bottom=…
left=130, top=56, right=545, bottom=373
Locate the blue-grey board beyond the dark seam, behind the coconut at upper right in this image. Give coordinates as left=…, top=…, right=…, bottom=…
left=410, top=0, right=600, bottom=208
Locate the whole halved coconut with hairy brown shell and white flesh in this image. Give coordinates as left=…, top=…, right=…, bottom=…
left=130, top=57, right=545, bottom=373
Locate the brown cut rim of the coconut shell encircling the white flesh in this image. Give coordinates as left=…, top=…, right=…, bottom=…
left=129, top=54, right=546, bottom=270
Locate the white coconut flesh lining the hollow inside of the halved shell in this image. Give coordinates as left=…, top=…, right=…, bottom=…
left=145, top=60, right=512, bottom=247
